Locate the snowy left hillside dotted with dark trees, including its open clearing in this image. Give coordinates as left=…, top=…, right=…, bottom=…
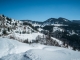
left=0, top=15, right=43, bottom=42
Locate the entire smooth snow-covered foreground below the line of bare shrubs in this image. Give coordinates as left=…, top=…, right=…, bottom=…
left=0, top=37, right=80, bottom=60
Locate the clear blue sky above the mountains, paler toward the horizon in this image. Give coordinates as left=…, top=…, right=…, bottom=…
left=0, top=0, right=80, bottom=21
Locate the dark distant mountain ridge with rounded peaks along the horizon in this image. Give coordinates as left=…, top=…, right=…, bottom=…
left=21, top=17, right=79, bottom=24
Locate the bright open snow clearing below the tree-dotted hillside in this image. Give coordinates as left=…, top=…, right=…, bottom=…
left=11, top=32, right=43, bottom=42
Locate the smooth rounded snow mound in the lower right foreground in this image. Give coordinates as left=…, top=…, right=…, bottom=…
left=26, top=47, right=80, bottom=60
